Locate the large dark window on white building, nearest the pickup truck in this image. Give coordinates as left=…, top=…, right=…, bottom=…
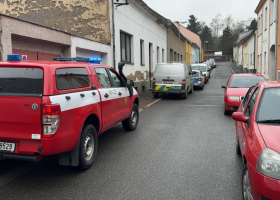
left=121, top=32, right=131, bottom=63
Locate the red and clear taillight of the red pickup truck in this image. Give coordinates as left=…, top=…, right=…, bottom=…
left=42, top=105, right=61, bottom=138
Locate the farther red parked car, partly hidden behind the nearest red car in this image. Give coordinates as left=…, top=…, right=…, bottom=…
left=222, top=74, right=265, bottom=115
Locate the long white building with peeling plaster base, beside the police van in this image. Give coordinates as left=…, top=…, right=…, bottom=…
left=114, top=0, right=167, bottom=92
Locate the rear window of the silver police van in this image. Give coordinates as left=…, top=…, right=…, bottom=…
left=155, top=64, right=184, bottom=76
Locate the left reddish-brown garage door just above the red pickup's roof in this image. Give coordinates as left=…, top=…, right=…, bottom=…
left=13, top=49, right=61, bottom=61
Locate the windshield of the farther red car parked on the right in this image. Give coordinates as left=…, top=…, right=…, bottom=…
left=229, top=76, right=265, bottom=88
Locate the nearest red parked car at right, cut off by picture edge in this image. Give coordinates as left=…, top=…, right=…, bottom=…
left=232, top=81, right=280, bottom=200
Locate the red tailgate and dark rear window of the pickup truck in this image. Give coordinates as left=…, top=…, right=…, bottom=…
left=0, top=66, right=43, bottom=144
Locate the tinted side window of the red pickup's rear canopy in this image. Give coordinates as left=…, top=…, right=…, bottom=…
left=56, top=68, right=90, bottom=90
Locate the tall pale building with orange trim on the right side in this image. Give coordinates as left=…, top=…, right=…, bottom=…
left=255, top=0, right=278, bottom=80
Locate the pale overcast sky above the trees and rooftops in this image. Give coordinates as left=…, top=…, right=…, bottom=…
left=144, top=0, right=259, bottom=26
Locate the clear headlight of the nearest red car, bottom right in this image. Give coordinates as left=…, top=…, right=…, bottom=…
left=257, top=148, right=280, bottom=180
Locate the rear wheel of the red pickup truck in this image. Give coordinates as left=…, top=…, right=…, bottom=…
left=79, top=124, right=98, bottom=170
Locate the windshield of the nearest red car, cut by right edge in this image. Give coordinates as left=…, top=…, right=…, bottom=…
left=257, top=88, right=280, bottom=123
